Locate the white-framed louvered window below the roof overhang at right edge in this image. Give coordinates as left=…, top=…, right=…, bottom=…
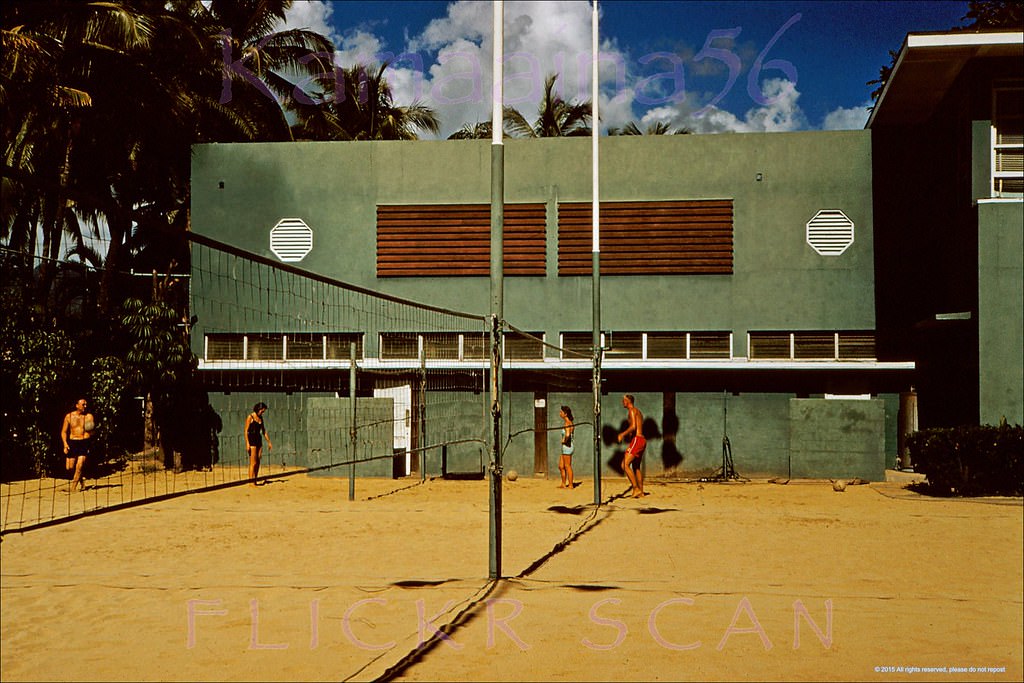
left=992, top=83, right=1024, bottom=197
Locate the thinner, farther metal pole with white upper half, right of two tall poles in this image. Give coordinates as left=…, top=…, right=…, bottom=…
left=590, top=0, right=602, bottom=505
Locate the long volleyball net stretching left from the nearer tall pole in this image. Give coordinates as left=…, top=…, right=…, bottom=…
left=0, top=234, right=592, bottom=531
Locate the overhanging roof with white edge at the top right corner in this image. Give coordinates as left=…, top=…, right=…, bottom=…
left=866, top=31, right=1024, bottom=128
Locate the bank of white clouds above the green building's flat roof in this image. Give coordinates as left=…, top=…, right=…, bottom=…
left=280, top=0, right=867, bottom=137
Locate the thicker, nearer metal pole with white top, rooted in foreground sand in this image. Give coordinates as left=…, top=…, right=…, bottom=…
left=488, top=0, right=505, bottom=580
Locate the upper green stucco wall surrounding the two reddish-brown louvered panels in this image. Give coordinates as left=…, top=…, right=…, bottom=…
left=193, top=131, right=874, bottom=355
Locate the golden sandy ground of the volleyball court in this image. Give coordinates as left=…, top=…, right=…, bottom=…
left=0, top=473, right=1024, bottom=681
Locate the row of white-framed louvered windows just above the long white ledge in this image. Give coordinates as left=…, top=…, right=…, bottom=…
left=204, top=331, right=876, bottom=360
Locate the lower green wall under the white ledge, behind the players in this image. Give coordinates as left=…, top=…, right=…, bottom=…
left=201, top=391, right=893, bottom=481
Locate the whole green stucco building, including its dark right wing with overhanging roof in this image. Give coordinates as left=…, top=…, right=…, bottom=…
left=191, top=29, right=1024, bottom=480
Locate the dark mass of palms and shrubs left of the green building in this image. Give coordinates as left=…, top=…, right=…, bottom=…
left=0, top=0, right=321, bottom=478
